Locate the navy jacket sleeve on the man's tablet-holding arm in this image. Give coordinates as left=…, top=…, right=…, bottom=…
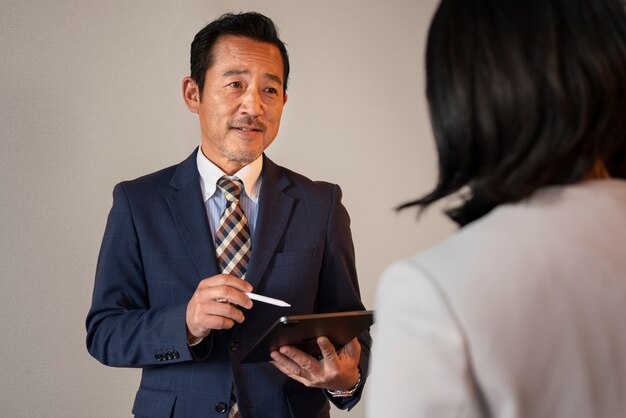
left=318, top=185, right=372, bottom=410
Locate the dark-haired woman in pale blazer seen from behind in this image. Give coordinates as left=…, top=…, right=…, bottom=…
left=368, top=0, right=626, bottom=418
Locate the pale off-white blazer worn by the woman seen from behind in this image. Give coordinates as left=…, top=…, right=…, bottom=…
left=366, top=180, right=626, bottom=418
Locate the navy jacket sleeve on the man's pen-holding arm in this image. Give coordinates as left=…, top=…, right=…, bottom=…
left=86, top=183, right=206, bottom=367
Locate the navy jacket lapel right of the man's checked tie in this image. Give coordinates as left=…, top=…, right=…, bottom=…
left=246, top=155, right=293, bottom=288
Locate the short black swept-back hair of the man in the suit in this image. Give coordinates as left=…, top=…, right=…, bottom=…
left=190, top=12, right=289, bottom=93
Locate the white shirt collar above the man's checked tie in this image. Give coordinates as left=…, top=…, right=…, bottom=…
left=196, top=147, right=263, bottom=203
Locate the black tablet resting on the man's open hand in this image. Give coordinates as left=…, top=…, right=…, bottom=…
left=241, top=311, right=374, bottom=363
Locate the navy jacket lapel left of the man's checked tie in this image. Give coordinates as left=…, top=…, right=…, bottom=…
left=167, top=148, right=219, bottom=279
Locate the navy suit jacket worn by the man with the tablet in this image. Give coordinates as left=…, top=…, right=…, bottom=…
left=86, top=152, right=371, bottom=418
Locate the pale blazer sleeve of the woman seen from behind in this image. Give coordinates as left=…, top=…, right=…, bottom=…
left=367, top=262, right=482, bottom=418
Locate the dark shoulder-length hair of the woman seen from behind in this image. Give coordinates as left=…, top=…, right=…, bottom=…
left=400, top=0, right=626, bottom=225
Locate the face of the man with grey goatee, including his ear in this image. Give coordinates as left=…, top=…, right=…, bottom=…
left=183, top=36, right=287, bottom=174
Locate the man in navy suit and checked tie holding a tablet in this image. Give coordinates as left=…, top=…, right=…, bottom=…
left=87, top=13, right=370, bottom=418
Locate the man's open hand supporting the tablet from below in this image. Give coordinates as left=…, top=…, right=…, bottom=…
left=271, top=337, right=361, bottom=390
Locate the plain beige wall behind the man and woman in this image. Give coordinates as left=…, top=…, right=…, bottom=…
left=0, top=0, right=452, bottom=418
